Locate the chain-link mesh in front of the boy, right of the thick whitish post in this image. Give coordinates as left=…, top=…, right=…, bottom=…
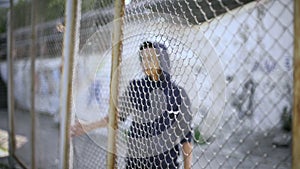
left=73, top=0, right=293, bottom=168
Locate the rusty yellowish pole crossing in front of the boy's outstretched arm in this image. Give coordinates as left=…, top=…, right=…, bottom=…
left=107, top=0, right=125, bottom=169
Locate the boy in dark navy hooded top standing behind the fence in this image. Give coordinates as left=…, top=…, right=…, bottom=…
left=72, top=41, right=192, bottom=169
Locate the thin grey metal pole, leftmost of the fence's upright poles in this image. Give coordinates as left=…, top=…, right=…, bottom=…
left=7, top=0, right=16, bottom=168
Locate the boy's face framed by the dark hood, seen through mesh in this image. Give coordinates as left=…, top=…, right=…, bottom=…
left=140, top=48, right=161, bottom=76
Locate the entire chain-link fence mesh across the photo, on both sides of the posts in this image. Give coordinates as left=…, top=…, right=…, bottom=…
left=1, top=0, right=294, bottom=169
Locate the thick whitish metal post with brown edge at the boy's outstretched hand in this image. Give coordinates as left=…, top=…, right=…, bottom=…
left=59, top=0, right=81, bottom=169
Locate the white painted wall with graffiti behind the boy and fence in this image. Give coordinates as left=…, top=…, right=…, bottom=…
left=0, top=0, right=293, bottom=136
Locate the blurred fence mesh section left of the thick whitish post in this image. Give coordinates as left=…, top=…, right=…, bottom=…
left=1, top=0, right=65, bottom=168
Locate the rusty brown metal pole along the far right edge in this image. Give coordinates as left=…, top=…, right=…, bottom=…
left=292, top=0, right=300, bottom=169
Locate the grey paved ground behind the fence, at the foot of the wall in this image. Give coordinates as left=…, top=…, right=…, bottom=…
left=0, top=110, right=292, bottom=169
